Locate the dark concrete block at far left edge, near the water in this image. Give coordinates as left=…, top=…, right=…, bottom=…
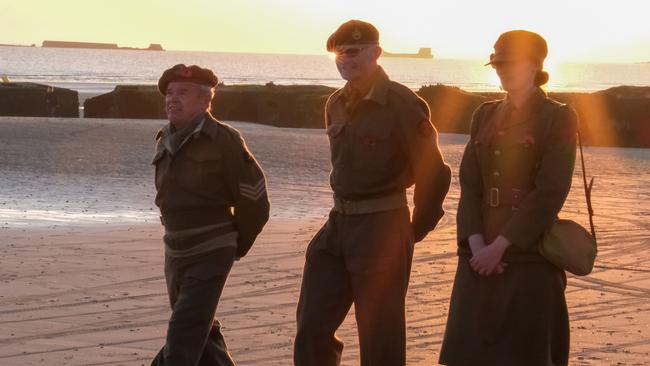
left=0, top=83, right=79, bottom=117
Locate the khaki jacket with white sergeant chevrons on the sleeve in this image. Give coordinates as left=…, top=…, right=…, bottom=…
left=152, top=113, right=270, bottom=257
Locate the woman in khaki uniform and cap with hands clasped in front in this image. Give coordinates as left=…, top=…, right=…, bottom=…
left=440, top=30, right=577, bottom=366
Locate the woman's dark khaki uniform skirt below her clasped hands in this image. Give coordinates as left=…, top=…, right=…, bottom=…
left=440, top=256, right=569, bottom=366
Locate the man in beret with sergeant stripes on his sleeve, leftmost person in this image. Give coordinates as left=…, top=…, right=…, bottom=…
left=152, top=64, right=269, bottom=366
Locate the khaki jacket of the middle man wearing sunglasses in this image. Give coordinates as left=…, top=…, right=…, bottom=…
left=325, top=67, right=451, bottom=231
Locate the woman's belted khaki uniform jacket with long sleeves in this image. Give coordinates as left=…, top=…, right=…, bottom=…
left=457, top=90, right=577, bottom=260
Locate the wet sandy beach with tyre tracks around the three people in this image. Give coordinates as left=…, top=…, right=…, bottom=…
left=0, top=117, right=650, bottom=366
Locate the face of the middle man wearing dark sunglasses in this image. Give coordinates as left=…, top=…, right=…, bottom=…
left=334, top=45, right=381, bottom=81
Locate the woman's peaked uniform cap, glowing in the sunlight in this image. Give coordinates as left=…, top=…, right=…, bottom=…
left=486, top=30, right=548, bottom=65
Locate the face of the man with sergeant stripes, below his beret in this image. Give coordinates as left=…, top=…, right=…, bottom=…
left=165, top=81, right=210, bottom=128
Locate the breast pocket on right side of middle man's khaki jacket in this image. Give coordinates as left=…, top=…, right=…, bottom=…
left=351, top=125, right=395, bottom=172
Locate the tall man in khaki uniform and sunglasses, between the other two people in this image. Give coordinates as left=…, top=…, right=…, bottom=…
left=294, top=20, right=450, bottom=366
